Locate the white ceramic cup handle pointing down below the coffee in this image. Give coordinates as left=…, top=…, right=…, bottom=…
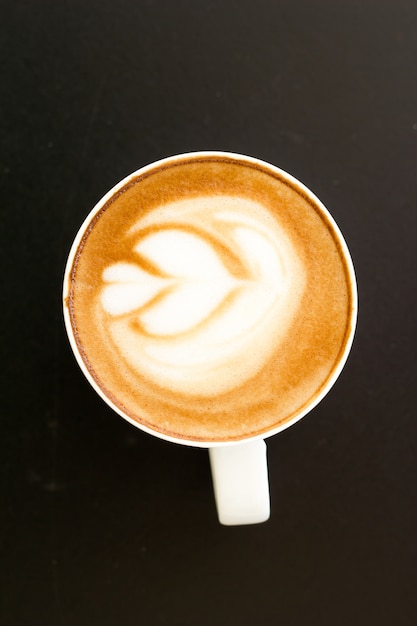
left=209, top=439, right=270, bottom=526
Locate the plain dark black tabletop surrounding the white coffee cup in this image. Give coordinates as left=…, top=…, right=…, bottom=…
left=0, top=0, right=417, bottom=626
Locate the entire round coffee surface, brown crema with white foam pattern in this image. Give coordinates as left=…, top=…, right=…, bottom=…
left=66, top=153, right=354, bottom=442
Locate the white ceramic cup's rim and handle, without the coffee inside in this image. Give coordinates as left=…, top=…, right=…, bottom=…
left=63, top=151, right=357, bottom=525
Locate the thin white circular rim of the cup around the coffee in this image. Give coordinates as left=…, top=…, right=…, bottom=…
left=62, top=150, right=358, bottom=448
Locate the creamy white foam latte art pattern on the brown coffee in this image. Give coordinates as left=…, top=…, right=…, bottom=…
left=100, top=196, right=304, bottom=396
